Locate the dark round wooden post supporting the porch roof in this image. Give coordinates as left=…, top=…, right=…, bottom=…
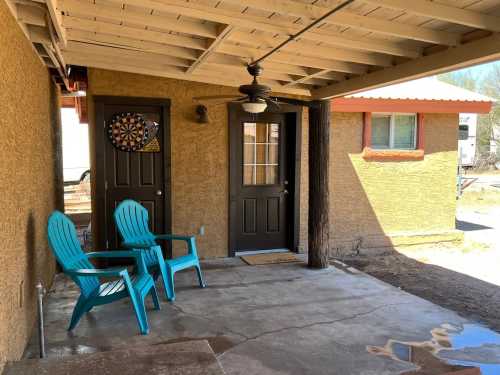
left=308, top=100, right=331, bottom=268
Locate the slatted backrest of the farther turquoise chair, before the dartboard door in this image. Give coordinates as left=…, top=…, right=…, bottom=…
left=114, top=199, right=157, bottom=246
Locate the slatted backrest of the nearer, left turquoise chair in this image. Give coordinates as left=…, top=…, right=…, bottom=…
left=47, top=211, right=99, bottom=295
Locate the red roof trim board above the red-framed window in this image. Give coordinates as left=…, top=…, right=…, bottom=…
left=331, top=98, right=492, bottom=113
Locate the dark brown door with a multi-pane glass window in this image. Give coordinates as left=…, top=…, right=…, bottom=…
left=230, top=110, right=289, bottom=252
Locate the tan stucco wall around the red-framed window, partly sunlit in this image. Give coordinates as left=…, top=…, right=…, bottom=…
left=330, top=112, right=458, bottom=253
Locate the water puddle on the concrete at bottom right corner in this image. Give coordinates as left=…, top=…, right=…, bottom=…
left=367, top=324, right=500, bottom=375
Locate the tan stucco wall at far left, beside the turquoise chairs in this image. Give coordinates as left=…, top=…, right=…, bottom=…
left=0, top=1, right=62, bottom=372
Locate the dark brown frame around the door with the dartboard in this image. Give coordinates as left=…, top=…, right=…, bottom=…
left=91, top=95, right=172, bottom=257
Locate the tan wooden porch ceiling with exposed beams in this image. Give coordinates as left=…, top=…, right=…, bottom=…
left=7, top=0, right=500, bottom=98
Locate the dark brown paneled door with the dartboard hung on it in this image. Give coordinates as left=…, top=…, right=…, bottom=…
left=96, top=97, right=170, bottom=256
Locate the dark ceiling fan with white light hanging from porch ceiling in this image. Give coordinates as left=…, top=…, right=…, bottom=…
left=193, top=64, right=279, bottom=113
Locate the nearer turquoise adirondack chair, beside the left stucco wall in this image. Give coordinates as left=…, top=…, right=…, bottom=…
left=47, top=211, right=160, bottom=335
